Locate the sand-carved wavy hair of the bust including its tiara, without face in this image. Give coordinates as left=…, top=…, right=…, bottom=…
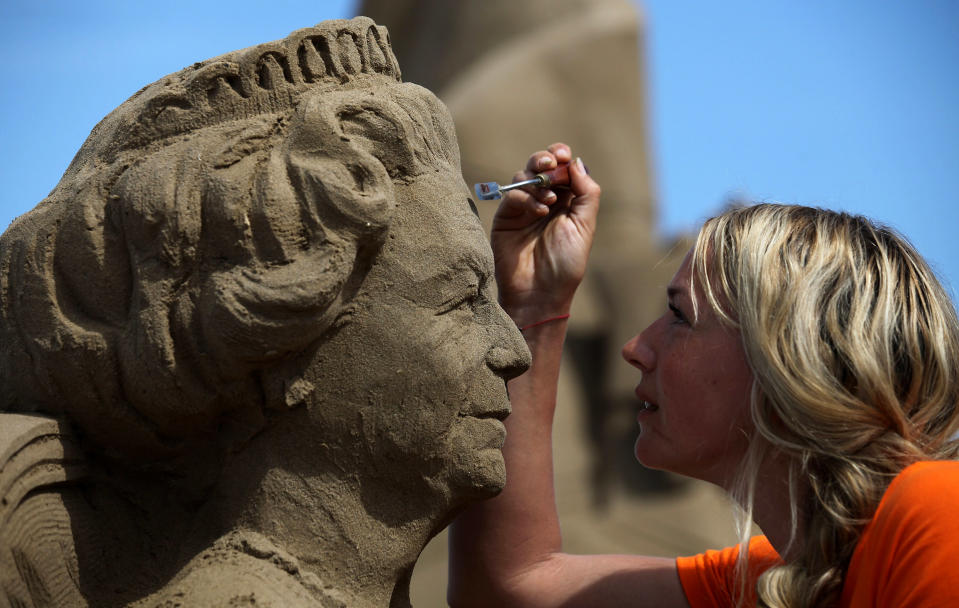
left=0, top=18, right=459, bottom=462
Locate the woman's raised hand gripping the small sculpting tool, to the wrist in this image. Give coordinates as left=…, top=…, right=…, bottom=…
left=491, top=143, right=600, bottom=327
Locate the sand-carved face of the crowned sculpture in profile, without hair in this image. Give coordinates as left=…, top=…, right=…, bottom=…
left=300, top=173, right=529, bottom=504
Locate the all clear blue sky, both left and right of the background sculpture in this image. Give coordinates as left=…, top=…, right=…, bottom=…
left=0, top=0, right=959, bottom=300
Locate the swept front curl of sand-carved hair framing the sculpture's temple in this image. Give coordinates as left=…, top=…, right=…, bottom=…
left=201, top=91, right=412, bottom=368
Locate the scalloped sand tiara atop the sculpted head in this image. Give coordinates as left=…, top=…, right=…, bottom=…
left=79, top=17, right=400, bottom=164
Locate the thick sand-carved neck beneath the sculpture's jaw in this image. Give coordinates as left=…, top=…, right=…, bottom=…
left=192, top=416, right=449, bottom=607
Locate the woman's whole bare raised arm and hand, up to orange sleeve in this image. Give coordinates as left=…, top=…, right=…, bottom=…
left=447, top=144, right=689, bottom=608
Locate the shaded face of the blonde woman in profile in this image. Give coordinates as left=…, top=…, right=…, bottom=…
left=623, top=254, right=753, bottom=487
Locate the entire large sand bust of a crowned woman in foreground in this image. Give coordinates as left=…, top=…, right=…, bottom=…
left=0, top=18, right=528, bottom=607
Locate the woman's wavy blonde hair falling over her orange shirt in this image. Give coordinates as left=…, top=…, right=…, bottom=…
left=692, top=204, right=959, bottom=606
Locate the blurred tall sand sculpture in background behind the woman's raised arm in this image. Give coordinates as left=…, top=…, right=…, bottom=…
left=358, top=0, right=748, bottom=608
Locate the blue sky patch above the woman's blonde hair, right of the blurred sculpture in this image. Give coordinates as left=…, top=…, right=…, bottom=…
left=645, top=0, right=959, bottom=299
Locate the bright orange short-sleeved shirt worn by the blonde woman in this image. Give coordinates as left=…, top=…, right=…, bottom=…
left=676, top=461, right=959, bottom=608
